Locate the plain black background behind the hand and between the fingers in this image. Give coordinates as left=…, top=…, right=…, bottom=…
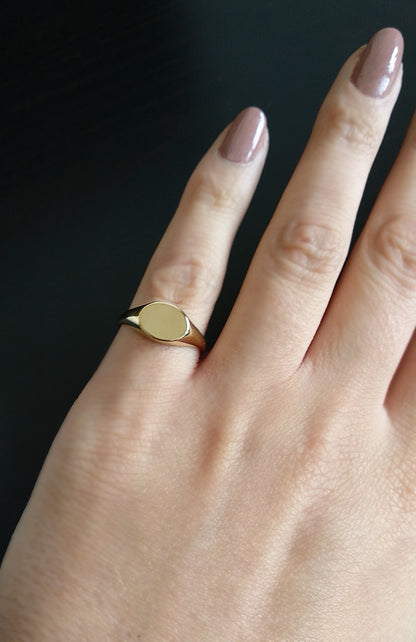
left=0, top=0, right=416, bottom=555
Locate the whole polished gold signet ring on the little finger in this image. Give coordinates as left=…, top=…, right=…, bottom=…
left=119, top=301, right=206, bottom=352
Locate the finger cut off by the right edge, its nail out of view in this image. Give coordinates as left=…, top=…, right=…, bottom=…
left=309, top=109, right=416, bottom=402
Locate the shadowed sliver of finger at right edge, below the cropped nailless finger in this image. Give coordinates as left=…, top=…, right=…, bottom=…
left=386, top=332, right=416, bottom=430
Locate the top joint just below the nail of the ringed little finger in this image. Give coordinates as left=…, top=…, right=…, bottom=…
left=186, top=168, right=241, bottom=212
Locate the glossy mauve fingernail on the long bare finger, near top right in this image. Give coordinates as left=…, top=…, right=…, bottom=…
left=351, top=27, right=403, bottom=98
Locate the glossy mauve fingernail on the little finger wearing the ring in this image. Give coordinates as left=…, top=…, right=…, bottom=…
left=219, top=107, right=266, bottom=163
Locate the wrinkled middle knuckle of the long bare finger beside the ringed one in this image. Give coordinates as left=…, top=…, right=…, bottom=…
left=272, top=220, right=345, bottom=278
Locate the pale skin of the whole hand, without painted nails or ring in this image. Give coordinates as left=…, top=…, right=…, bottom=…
left=0, top=31, right=416, bottom=642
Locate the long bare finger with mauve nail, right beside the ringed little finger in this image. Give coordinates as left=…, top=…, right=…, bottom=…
left=208, top=29, right=402, bottom=376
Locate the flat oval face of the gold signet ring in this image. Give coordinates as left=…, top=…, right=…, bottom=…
left=139, top=301, right=189, bottom=341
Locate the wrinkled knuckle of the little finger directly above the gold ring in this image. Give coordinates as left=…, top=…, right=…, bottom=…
left=148, top=257, right=218, bottom=306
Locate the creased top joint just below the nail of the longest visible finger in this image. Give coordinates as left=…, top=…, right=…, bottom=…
left=321, top=101, right=380, bottom=152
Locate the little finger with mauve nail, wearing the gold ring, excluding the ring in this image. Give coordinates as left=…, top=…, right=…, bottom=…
left=98, top=107, right=268, bottom=377
